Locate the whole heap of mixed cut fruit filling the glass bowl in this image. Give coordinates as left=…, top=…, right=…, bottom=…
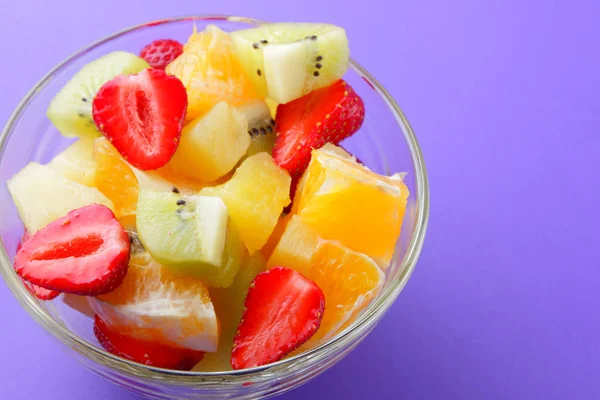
left=7, top=23, right=409, bottom=371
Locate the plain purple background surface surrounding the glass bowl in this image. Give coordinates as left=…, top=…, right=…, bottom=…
left=0, top=0, right=600, bottom=400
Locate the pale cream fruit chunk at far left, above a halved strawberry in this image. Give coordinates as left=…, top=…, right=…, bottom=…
left=7, top=162, right=113, bottom=234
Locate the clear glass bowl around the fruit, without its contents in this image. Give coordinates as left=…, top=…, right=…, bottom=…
left=0, top=16, right=429, bottom=399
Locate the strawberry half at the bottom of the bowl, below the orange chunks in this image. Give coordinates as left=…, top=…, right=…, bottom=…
left=231, top=267, right=325, bottom=369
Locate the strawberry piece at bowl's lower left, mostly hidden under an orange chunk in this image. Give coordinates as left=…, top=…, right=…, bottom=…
left=94, top=315, right=204, bottom=371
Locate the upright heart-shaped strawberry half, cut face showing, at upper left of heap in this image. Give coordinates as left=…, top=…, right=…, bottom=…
left=92, top=69, right=187, bottom=170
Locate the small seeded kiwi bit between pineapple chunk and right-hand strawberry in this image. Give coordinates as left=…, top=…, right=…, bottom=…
left=237, top=100, right=275, bottom=158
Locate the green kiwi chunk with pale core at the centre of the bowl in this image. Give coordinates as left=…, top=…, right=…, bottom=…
left=136, top=188, right=244, bottom=287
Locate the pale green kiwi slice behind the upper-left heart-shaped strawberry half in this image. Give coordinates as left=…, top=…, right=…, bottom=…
left=46, top=51, right=150, bottom=137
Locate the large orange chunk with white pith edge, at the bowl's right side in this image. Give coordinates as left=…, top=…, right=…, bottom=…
left=293, top=145, right=408, bottom=268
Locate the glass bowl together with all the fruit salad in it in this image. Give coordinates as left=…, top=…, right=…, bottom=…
left=0, top=16, right=428, bottom=398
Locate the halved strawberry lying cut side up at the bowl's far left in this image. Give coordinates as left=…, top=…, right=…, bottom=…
left=15, top=204, right=129, bottom=296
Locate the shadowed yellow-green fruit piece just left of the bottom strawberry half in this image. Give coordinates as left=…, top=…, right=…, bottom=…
left=194, top=253, right=265, bottom=372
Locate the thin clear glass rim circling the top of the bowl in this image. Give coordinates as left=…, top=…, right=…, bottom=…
left=0, top=14, right=429, bottom=384
